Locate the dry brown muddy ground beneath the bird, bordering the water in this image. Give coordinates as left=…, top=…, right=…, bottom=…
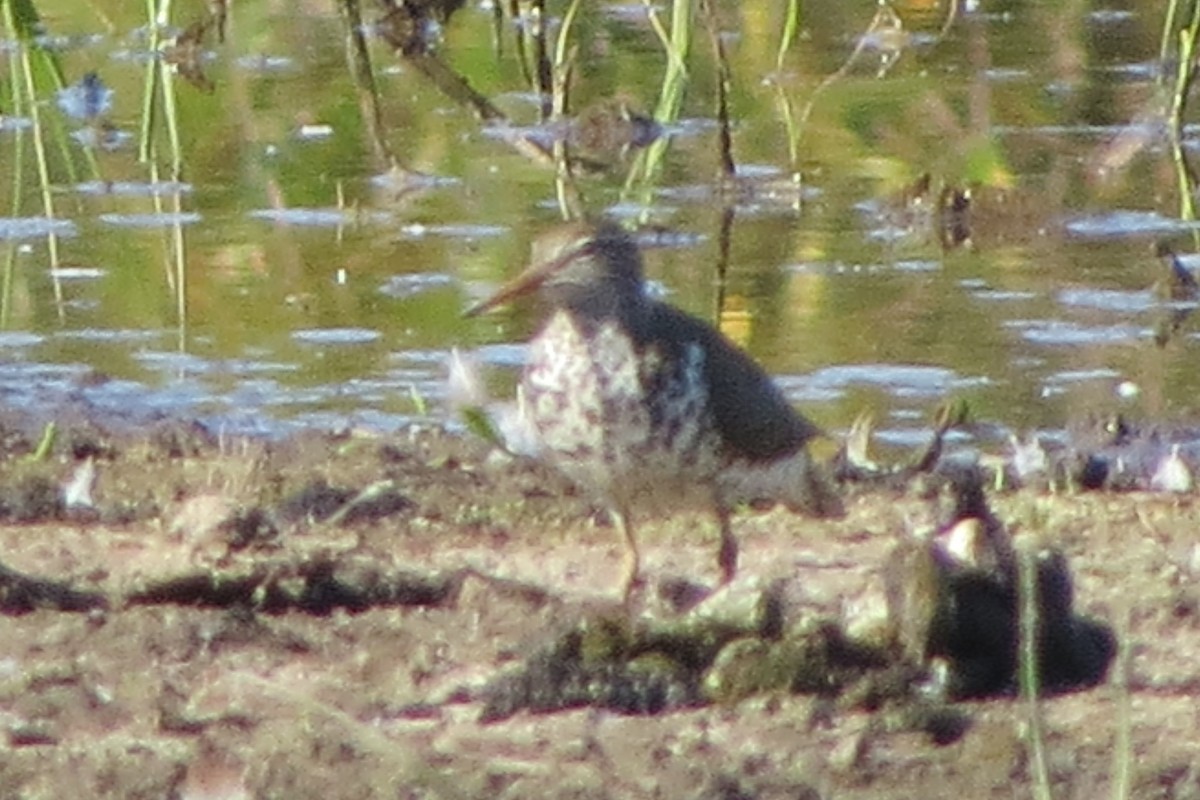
left=0, top=417, right=1200, bottom=800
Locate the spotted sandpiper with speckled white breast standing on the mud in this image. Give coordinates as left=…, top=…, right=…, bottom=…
left=467, top=222, right=842, bottom=601
